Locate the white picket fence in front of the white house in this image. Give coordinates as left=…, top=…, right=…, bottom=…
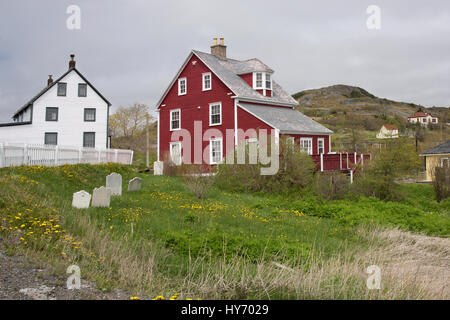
left=0, top=143, right=133, bottom=168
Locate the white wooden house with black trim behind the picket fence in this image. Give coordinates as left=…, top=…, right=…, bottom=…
left=0, top=55, right=111, bottom=148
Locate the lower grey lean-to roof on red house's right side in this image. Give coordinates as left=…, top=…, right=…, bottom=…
left=238, top=103, right=333, bottom=135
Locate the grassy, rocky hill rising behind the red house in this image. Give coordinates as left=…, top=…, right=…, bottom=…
left=292, top=84, right=450, bottom=151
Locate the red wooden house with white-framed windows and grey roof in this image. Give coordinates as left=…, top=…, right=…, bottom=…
left=156, top=38, right=368, bottom=171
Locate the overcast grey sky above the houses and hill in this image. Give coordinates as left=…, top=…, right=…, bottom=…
left=0, top=0, right=450, bottom=122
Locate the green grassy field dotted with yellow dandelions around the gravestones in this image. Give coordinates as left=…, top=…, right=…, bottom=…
left=0, top=164, right=450, bottom=299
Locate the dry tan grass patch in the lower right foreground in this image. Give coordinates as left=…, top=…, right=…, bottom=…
left=177, top=225, right=450, bottom=299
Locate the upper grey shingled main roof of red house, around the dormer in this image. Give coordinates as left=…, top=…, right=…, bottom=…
left=192, top=50, right=298, bottom=105
